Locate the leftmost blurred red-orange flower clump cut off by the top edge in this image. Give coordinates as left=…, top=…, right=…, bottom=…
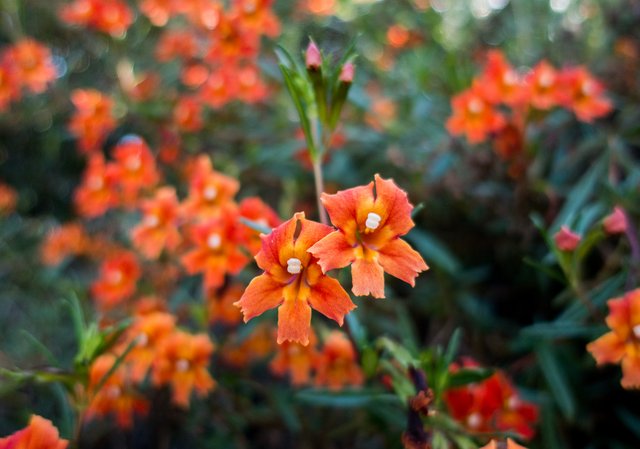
left=60, top=0, right=134, bottom=37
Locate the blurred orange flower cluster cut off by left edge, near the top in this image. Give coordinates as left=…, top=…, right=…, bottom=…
left=0, top=38, right=58, bottom=112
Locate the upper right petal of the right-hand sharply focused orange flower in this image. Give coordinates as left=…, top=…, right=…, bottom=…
left=375, top=174, right=415, bottom=235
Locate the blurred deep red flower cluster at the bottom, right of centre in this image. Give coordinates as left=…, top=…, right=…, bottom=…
left=444, top=359, right=538, bottom=439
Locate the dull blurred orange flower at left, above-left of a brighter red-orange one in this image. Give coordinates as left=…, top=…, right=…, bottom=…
left=40, top=223, right=89, bottom=265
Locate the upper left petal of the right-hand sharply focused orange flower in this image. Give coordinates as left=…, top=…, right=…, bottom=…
left=321, top=182, right=373, bottom=236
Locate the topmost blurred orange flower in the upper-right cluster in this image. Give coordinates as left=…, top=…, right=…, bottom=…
left=478, top=50, right=527, bottom=106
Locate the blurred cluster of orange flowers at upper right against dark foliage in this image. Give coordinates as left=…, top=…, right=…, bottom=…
left=446, top=50, right=612, bottom=160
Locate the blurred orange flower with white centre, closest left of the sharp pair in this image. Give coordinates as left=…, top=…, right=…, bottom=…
left=181, top=206, right=249, bottom=290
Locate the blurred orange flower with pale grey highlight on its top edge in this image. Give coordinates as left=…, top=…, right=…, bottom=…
left=107, top=134, right=160, bottom=206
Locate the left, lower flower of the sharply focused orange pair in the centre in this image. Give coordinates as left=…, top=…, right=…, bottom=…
left=236, top=212, right=356, bottom=345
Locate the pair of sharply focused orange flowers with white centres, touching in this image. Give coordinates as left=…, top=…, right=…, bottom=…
left=237, top=175, right=428, bottom=345
